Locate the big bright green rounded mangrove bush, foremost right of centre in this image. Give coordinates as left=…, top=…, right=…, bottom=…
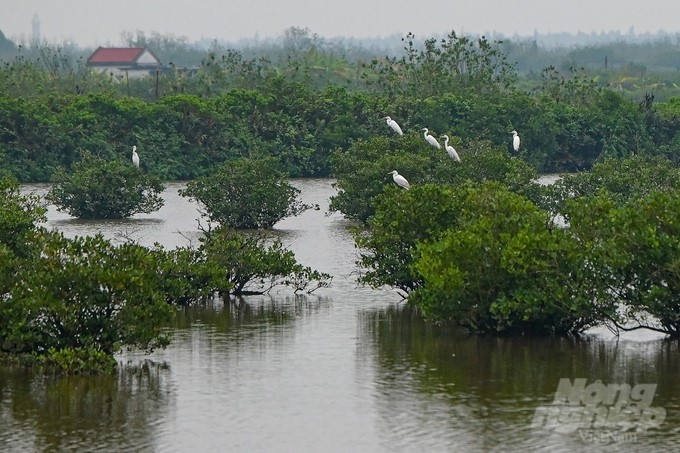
left=410, top=184, right=614, bottom=335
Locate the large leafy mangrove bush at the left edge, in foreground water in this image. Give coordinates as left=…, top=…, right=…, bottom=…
left=0, top=179, right=172, bottom=373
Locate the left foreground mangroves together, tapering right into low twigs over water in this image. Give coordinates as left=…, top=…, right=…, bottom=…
left=0, top=173, right=331, bottom=373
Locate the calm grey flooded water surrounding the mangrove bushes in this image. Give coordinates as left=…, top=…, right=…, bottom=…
left=0, top=180, right=680, bottom=452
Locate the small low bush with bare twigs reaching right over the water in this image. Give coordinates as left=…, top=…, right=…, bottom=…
left=200, top=226, right=331, bottom=295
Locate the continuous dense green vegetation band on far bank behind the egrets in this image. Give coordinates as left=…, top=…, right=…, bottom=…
left=0, top=32, right=679, bottom=181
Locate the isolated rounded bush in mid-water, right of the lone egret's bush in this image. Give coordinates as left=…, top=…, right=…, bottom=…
left=180, top=159, right=308, bottom=229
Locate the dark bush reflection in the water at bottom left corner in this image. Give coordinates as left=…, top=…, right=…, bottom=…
left=0, top=361, right=173, bottom=451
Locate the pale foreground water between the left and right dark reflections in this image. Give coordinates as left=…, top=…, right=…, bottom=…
left=143, top=296, right=386, bottom=452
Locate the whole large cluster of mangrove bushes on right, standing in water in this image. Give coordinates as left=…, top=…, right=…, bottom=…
left=357, top=157, right=680, bottom=337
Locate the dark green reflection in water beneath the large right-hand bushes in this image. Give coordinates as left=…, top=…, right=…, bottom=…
left=359, top=305, right=680, bottom=450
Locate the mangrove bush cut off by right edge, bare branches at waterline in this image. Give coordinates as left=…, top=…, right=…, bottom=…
left=566, top=191, right=680, bottom=337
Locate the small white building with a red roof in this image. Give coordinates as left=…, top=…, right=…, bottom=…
left=87, top=47, right=161, bottom=78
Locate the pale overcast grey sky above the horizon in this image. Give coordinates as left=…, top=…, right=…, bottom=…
left=0, top=0, right=680, bottom=46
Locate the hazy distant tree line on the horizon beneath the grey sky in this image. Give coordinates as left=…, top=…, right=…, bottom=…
left=0, top=27, right=680, bottom=100
